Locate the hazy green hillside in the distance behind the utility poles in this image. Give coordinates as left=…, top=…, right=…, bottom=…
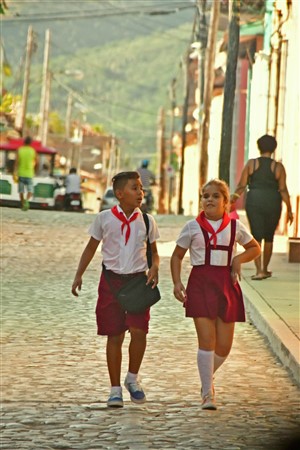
left=2, top=0, right=194, bottom=167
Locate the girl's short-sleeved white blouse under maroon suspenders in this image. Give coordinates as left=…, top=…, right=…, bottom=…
left=176, top=219, right=253, bottom=266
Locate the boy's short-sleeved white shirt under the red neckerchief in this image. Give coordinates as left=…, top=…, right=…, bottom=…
left=88, top=205, right=159, bottom=274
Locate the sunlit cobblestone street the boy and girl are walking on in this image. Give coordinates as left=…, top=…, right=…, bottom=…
left=0, top=208, right=299, bottom=450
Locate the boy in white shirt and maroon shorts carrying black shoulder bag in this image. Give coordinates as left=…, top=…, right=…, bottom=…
left=72, top=172, right=159, bottom=407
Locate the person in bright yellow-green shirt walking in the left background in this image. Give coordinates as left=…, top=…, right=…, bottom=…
left=14, top=136, right=37, bottom=211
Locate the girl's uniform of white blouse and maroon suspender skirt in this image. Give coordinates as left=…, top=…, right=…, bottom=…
left=176, top=219, right=253, bottom=322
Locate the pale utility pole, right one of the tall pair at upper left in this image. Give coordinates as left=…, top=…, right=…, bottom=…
left=39, top=29, right=51, bottom=145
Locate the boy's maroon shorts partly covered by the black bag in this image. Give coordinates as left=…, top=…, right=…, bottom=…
left=95, top=273, right=150, bottom=336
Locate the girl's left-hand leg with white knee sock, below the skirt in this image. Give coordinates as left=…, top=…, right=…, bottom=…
left=194, top=317, right=216, bottom=398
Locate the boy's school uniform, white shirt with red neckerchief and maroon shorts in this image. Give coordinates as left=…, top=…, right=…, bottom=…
left=88, top=205, right=159, bottom=336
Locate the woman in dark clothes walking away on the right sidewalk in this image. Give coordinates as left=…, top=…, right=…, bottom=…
left=231, top=134, right=293, bottom=280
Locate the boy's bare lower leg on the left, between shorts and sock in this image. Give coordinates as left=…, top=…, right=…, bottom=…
left=106, top=333, right=125, bottom=386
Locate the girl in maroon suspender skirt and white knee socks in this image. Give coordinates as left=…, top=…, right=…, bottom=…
left=171, top=179, right=260, bottom=410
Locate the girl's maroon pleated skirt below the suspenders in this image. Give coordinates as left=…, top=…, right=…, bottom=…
left=185, top=265, right=246, bottom=322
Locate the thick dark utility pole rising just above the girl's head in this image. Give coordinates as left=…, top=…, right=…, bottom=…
left=219, top=0, right=240, bottom=184
